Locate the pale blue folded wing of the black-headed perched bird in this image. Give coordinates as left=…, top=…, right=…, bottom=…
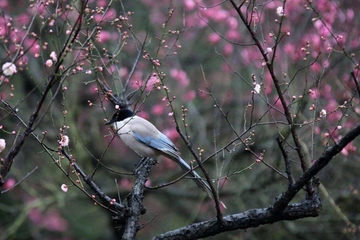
left=132, top=130, right=179, bottom=158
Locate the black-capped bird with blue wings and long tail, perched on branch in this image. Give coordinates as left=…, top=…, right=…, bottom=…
left=105, top=108, right=213, bottom=198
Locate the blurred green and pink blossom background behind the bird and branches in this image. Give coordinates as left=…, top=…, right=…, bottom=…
left=0, top=0, right=360, bottom=239
